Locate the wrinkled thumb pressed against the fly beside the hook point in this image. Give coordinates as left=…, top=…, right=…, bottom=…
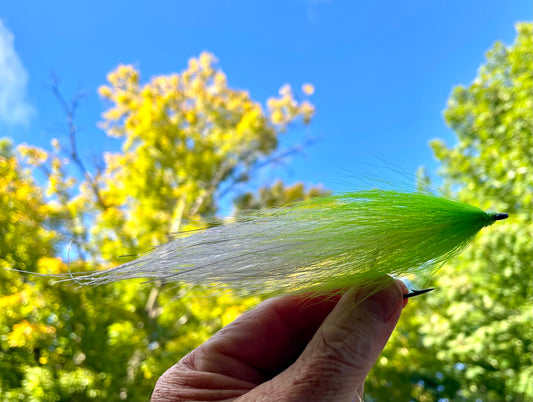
left=281, top=281, right=403, bottom=401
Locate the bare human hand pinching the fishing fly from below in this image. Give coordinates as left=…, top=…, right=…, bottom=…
left=151, top=281, right=407, bottom=402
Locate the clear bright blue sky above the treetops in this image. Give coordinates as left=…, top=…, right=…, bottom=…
left=0, top=0, right=533, bottom=199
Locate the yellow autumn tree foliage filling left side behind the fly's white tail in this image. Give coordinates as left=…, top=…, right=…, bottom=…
left=0, top=53, right=314, bottom=401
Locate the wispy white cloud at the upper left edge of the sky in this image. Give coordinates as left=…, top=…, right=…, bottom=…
left=0, top=19, right=35, bottom=126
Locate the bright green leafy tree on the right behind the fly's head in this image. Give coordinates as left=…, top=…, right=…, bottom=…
left=367, top=23, right=533, bottom=401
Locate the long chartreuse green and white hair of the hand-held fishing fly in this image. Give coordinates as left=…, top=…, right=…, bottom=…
left=64, top=190, right=507, bottom=296
